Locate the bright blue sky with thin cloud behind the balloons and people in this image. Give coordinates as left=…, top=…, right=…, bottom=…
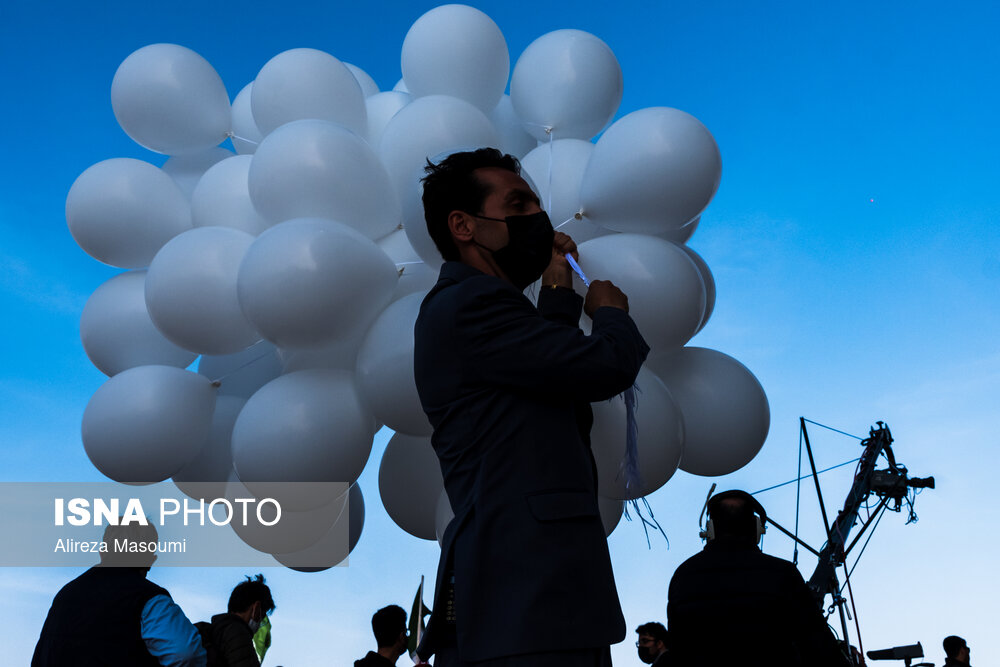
left=0, top=0, right=1000, bottom=667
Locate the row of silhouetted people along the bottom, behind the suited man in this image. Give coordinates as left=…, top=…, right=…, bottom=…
left=31, top=491, right=969, bottom=667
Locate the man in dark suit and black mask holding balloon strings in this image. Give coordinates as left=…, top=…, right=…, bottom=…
left=414, top=149, right=649, bottom=667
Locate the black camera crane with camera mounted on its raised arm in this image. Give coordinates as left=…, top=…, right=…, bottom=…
left=768, top=417, right=934, bottom=664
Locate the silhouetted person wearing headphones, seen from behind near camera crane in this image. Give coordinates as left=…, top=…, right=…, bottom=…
left=667, top=491, right=847, bottom=667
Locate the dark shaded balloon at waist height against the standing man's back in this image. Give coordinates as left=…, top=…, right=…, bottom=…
left=378, top=433, right=444, bottom=540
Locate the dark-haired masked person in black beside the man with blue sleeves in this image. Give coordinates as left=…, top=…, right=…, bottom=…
left=208, top=574, right=274, bottom=667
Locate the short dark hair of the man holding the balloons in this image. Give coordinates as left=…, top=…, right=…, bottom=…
left=422, top=148, right=521, bottom=262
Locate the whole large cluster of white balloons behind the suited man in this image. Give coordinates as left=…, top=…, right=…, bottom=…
left=66, top=5, right=769, bottom=565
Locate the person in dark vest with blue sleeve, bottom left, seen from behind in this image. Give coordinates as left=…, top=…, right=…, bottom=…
left=31, top=525, right=206, bottom=667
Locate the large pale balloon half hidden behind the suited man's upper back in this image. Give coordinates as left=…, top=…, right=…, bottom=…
left=356, top=292, right=434, bottom=436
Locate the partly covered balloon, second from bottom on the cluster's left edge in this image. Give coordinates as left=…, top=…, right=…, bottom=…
left=80, top=271, right=198, bottom=375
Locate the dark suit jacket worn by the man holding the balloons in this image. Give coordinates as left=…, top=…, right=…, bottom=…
left=414, top=262, right=649, bottom=661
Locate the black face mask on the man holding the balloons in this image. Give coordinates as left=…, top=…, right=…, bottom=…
left=473, top=211, right=556, bottom=290
